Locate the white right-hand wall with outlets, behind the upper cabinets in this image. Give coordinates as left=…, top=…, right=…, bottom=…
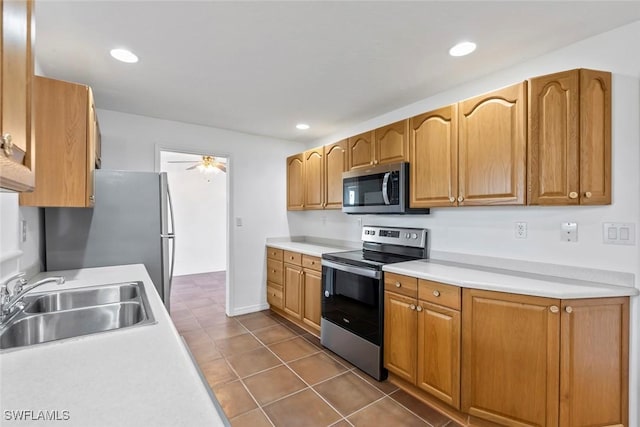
left=288, top=22, right=640, bottom=426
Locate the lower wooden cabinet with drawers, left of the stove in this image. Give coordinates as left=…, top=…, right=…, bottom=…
left=267, top=247, right=322, bottom=335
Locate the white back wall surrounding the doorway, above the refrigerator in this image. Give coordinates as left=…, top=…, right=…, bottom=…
left=98, top=110, right=304, bottom=315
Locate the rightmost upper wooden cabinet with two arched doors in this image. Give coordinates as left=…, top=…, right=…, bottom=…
left=527, top=69, right=611, bottom=205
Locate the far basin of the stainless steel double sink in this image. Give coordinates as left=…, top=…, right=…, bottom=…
left=24, top=283, right=140, bottom=313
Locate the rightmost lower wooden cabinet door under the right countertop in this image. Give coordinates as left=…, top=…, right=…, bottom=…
left=560, top=297, right=629, bottom=427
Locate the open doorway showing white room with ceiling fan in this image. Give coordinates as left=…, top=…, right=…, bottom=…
left=159, top=150, right=228, bottom=318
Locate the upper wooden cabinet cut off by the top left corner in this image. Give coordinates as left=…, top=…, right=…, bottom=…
left=0, top=0, right=35, bottom=191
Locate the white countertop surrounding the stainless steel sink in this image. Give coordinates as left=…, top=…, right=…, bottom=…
left=0, top=265, right=229, bottom=427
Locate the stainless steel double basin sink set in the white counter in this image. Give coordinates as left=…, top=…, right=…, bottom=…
left=0, top=282, right=155, bottom=350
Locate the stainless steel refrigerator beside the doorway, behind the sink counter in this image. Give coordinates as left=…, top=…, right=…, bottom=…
left=44, top=169, right=175, bottom=310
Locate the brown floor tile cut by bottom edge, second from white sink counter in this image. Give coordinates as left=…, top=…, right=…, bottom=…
left=262, top=389, right=342, bottom=427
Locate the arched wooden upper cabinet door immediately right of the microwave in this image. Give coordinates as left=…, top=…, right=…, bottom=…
left=409, top=104, right=458, bottom=208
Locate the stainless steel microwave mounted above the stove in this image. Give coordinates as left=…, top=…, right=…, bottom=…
left=342, top=162, right=429, bottom=214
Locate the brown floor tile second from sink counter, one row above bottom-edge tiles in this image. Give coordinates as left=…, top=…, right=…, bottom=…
left=243, top=365, right=306, bottom=405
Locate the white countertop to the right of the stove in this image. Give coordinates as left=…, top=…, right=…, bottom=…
left=383, top=260, right=639, bottom=299
